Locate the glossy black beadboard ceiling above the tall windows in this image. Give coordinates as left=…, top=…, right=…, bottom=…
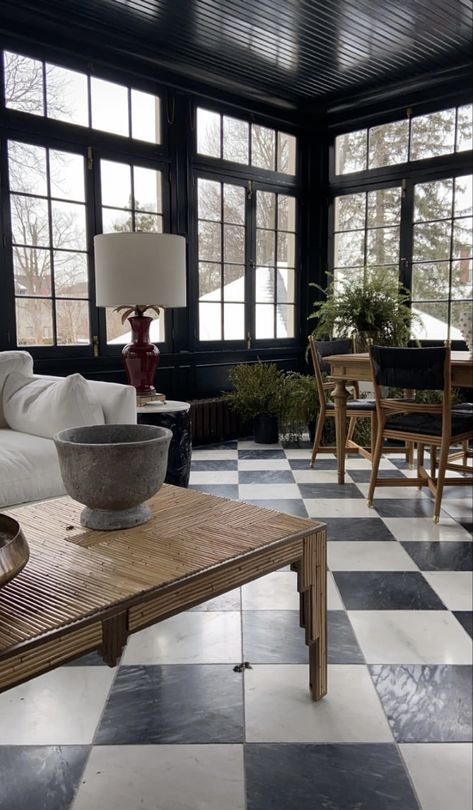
left=1, top=0, right=472, bottom=108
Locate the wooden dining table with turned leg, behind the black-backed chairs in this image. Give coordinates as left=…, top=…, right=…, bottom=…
left=324, top=352, right=473, bottom=484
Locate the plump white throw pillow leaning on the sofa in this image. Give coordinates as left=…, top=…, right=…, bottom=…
left=3, top=372, right=105, bottom=439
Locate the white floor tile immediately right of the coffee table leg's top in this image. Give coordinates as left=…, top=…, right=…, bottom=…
left=327, top=540, right=419, bottom=571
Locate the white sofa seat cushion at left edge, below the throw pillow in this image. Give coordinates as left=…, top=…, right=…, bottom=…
left=0, top=428, right=65, bottom=508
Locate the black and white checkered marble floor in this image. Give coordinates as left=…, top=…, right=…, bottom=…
left=0, top=442, right=472, bottom=810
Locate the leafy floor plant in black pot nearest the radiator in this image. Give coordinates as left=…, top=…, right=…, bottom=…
left=223, top=361, right=284, bottom=444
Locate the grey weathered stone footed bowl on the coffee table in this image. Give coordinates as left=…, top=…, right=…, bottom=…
left=54, top=425, right=172, bottom=531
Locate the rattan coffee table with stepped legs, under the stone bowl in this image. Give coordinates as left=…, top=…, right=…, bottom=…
left=0, top=485, right=327, bottom=700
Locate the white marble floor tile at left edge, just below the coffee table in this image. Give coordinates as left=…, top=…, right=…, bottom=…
left=0, top=667, right=115, bottom=745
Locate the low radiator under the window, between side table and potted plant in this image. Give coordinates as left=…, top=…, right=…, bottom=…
left=190, top=397, right=251, bottom=446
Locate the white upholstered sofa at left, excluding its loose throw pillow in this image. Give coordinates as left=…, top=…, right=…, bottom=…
left=0, top=351, right=136, bottom=508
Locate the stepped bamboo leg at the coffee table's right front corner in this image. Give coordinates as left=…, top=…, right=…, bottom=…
left=296, top=531, right=327, bottom=700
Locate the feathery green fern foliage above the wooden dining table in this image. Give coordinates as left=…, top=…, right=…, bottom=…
left=309, top=270, right=415, bottom=351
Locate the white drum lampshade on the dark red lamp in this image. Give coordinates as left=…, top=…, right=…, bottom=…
left=94, top=237, right=186, bottom=307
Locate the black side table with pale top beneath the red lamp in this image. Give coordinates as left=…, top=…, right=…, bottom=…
left=137, top=400, right=192, bottom=487
